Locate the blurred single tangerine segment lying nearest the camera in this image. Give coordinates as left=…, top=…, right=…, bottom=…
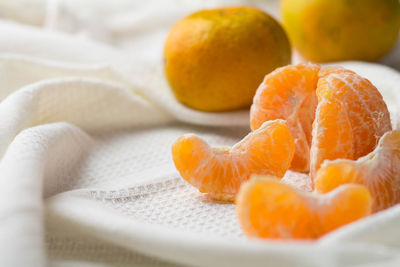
left=236, top=176, right=372, bottom=239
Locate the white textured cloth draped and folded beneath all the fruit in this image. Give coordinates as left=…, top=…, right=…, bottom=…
left=0, top=0, right=400, bottom=266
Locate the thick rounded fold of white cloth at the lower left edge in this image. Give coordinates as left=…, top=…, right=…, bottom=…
left=0, top=123, right=90, bottom=266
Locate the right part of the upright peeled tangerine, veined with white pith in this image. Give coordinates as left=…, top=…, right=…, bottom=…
left=310, top=70, right=391, bottom=180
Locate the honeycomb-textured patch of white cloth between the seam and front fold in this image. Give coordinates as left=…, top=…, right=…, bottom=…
left=92, top=178, right=244, bottom=240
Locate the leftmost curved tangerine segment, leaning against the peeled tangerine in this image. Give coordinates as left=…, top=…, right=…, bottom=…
left=172, top=120, right=294, bottom=201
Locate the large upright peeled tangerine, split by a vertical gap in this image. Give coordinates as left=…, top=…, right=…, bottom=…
left=250, top=64, right=391, bottom=176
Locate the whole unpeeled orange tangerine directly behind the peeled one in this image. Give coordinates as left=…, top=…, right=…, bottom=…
left=164, top=7, right=291, bottom=111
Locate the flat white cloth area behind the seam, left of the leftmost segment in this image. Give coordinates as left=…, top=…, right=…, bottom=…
left=45, top=123, right=249, bottom=194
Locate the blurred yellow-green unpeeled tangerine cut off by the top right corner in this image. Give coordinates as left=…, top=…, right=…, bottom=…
left=281, top=0, right=400, bottom=62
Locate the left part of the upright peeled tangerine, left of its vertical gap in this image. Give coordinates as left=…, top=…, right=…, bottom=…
left=250, top=64, right=320, bottom=172
